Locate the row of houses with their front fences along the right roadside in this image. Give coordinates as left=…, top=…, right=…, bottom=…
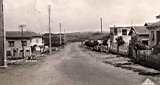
left=110, top=16, right=160, bottom=69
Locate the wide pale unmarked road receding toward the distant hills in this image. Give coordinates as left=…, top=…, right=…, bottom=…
left=0, top=43, right=144, bottom=85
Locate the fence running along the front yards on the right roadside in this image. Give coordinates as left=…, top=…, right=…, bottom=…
left=83, top=43, right=160, bottom=70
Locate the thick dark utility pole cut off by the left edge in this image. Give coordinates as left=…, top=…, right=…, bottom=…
left=0, top=0, right=7, bottom=68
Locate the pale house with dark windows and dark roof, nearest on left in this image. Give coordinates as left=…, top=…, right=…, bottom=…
left=6, top=31, right=43, bottom=59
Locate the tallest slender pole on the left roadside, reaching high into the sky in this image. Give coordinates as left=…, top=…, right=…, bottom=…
left=48, top=5, right=52, bottom=55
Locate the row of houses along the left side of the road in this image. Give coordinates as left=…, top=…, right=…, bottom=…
left=5, top=31, right=64, bottom=59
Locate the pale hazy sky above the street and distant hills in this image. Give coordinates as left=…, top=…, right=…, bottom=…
left=4, top=0, right=160, bottom=32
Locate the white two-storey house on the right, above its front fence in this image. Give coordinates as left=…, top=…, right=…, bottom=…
left=110, top=26, right=149, bottom=45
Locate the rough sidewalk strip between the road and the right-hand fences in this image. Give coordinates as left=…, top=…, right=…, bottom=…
left=85, top=49, right=160, bottom=76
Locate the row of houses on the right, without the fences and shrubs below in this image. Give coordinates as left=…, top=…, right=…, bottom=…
left=110, top=21, right=160, bottom=53
